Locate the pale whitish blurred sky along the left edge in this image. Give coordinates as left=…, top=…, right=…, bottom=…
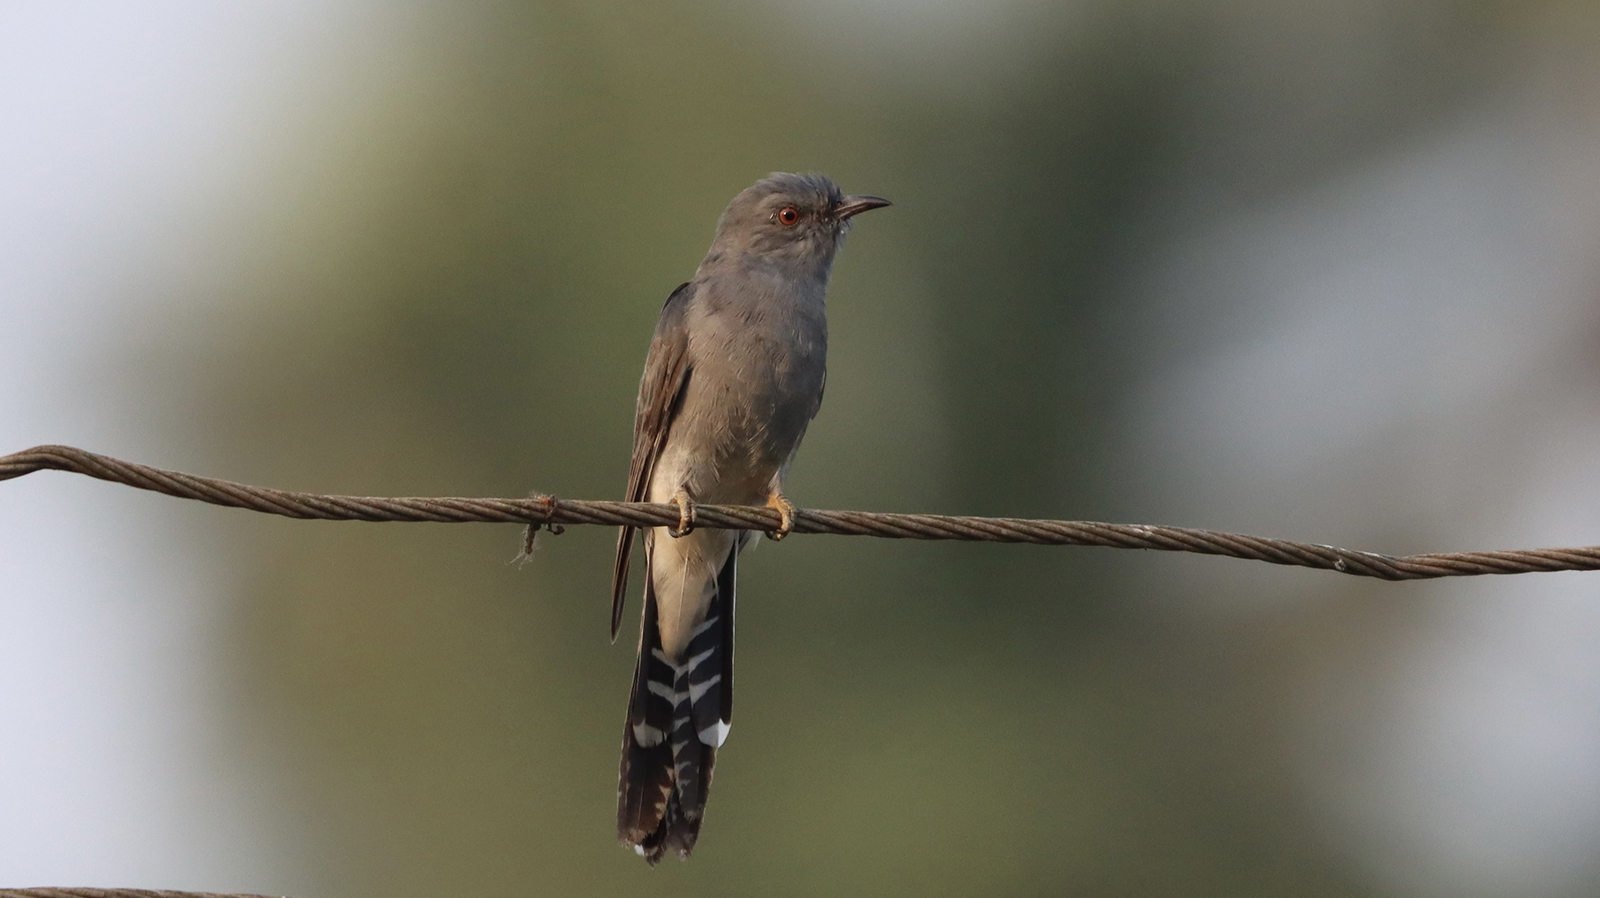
left=0, top=2, right=405, bottom=890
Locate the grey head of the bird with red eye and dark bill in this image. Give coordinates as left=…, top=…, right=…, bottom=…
left=701, top=171, right=890, bottom=275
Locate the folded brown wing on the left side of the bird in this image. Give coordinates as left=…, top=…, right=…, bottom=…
left=611, top=283, right=694, bottom=640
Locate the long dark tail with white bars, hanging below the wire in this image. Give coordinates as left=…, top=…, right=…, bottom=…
left=616, top=546, right=739, bottom=864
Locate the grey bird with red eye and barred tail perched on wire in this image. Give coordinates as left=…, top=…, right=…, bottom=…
left=611, top=173, right=890, bottom=863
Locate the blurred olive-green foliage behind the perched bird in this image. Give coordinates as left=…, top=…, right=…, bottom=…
left=144, top=0, right=1542, bottom=898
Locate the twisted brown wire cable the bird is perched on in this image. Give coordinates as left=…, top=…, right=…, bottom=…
left=0, top=445, right=1600, bottom=582
